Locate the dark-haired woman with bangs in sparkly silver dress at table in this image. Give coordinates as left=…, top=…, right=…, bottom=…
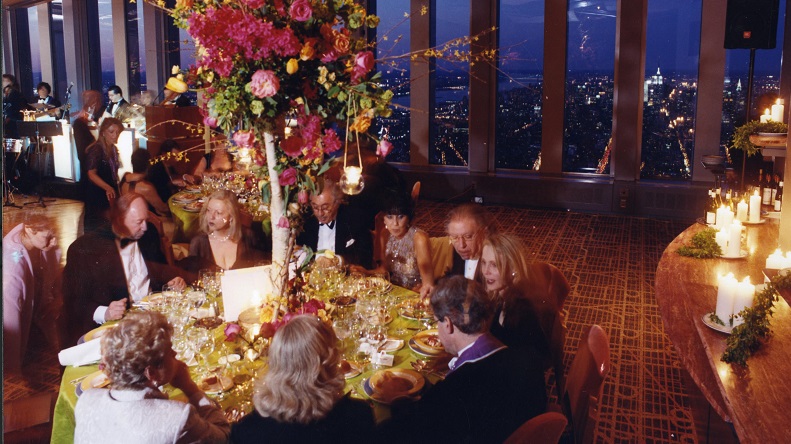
left=352, top=195, right=434, bottom=297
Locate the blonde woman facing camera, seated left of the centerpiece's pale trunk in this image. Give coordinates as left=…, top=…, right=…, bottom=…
left=186, top=190, right=263, bottom=270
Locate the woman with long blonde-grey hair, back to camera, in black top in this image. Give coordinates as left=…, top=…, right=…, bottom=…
left=231, top=315, right=374, bottom=444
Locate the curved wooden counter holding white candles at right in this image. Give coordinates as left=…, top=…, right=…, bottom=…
left=655, top=218, right=791, bottom=443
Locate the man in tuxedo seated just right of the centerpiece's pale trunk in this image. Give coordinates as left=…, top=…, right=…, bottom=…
left=297, top=179, right=373, bottom=269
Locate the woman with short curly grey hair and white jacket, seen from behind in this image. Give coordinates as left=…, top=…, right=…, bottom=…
left=74, top=311, right=230, bottom=443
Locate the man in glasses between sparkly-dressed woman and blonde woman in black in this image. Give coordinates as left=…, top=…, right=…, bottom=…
left=445, top=204, right=497, bottom=279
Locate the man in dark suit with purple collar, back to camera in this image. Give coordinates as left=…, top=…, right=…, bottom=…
left=381, top=276, right=547, bottom=443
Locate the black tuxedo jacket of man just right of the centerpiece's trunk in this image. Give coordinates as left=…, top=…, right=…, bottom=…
left=297, top=205, right=374, bottom=269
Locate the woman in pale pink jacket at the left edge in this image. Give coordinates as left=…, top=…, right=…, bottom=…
left=3, top=212, right=61, bottom=373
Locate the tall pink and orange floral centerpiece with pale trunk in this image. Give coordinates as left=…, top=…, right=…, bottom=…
left=170, top=0, right=400, bottom=295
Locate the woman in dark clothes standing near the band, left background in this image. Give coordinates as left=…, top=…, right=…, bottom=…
left=85, top=117, right=124, bottom=228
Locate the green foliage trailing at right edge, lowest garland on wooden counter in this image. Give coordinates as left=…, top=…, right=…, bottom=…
left=721, top=273, right=791, bottom=367
